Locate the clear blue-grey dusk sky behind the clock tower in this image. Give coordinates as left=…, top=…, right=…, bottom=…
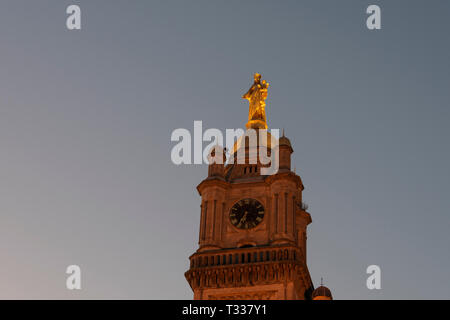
left=0, top=0, right=450, bottom=299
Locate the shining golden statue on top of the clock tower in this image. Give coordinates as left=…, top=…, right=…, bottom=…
left=242, top=73, right=269, bottom=129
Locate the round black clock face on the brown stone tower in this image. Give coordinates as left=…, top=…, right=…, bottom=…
left=230, top=199, right=264, bottom=229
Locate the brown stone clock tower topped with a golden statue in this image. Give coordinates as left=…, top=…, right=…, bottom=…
left=185, top=74, right=313, bottom=300
